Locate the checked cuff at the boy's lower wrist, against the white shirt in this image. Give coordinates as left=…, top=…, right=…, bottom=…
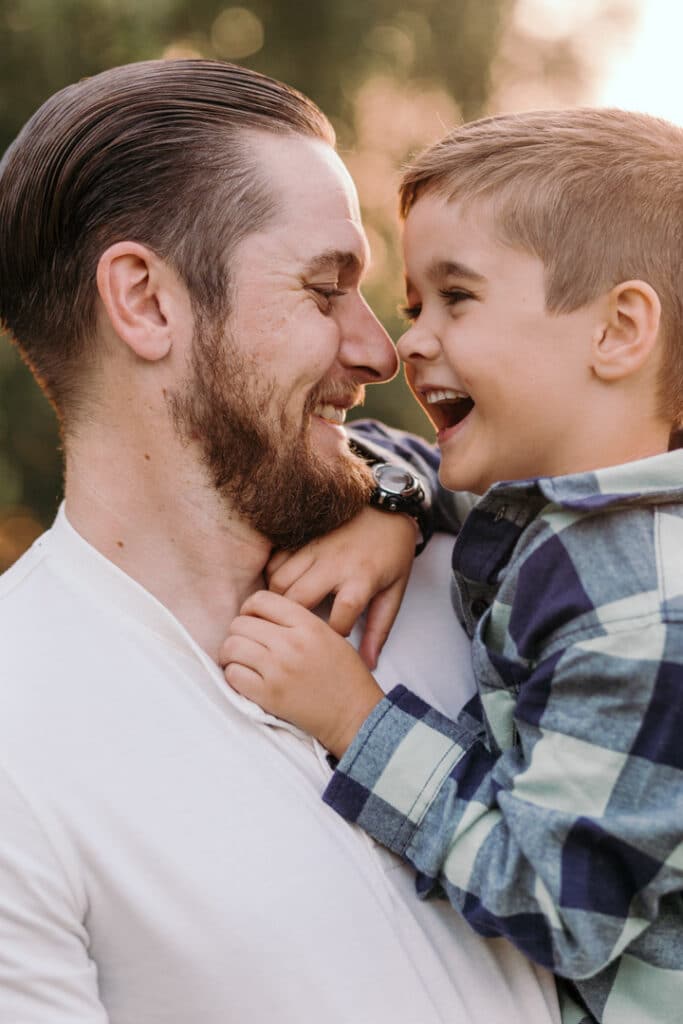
left=323, top=686, right=479, bottom=855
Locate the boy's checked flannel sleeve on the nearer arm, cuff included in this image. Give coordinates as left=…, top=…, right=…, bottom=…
left=325, top=608, right=683, bottom=979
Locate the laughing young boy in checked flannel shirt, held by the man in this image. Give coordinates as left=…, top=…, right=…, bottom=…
left=223, top=110, right=683, bottom=1024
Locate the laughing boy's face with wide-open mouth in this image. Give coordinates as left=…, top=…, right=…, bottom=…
left=398, top=195, right=604, bottom=494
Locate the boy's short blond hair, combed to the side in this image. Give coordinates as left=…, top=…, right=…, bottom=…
left=400, top=108, right=683, bottom=426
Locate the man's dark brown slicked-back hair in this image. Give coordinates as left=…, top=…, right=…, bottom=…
left=0, top=59, right=334, bottom=419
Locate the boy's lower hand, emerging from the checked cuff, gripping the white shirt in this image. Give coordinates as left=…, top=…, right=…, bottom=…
left=220, top=591, right=384, bottom=758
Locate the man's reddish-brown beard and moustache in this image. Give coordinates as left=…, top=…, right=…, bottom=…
left=169, top=317, right=373, bottom=549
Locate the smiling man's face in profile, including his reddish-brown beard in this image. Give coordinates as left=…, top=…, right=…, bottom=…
left=167, top=133, right=397, bottom=547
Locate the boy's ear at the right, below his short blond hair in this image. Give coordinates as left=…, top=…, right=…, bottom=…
left=592, top=281, right=661, bottom=381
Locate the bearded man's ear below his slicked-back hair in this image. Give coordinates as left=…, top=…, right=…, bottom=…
left=97, top=242, right=177, bottom=361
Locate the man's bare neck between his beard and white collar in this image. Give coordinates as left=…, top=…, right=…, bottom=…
left=66, top=445, right=270, bottom=659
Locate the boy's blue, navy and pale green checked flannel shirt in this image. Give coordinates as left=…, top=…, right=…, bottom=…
left=339, top=424, right=683, bottom=1024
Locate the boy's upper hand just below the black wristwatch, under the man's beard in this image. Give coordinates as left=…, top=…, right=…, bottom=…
left=266, top=506, right=417, bottom=669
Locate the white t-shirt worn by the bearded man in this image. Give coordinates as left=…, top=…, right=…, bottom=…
left=0, top=510, right=559, bottom=1024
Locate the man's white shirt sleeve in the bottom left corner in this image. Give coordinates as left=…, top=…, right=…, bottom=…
left=0, top=771, right=109, bottom=1024
